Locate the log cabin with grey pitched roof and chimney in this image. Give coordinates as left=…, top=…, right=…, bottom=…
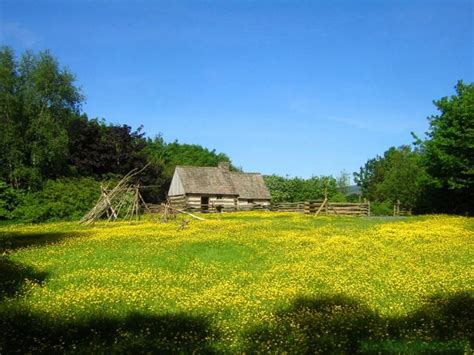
left=168, top=162, right=271, bottom=211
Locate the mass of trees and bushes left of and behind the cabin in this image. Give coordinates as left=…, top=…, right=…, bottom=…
left=0, top=47, right=236, bottom=222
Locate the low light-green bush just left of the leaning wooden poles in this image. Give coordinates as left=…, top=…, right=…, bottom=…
left=13, top=178, right=108, bottom=223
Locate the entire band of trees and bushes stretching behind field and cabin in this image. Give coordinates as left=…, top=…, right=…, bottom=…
left=0, top=47, right=474, bottom=222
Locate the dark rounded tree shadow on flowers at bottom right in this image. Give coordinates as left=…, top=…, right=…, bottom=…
left=244, top=293, right=474, bottom=354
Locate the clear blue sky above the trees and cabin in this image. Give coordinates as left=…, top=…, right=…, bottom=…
left=0, top=0, right=474, bottom=177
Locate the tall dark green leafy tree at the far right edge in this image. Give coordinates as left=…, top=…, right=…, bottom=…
left=415, top=81, right=474, bottom=214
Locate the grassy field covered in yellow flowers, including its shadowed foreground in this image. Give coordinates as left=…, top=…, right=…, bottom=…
left=0, top=212, right=474, bottom=353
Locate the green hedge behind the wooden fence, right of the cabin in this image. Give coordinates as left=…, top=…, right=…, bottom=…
left=264, top=175, right=341, bottom=202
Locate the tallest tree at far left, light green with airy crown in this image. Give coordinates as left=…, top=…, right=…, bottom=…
left=0, top=48, right=83, bottom=188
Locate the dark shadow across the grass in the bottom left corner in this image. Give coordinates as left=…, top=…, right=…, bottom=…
left=0, top=309, right=217, bottom=354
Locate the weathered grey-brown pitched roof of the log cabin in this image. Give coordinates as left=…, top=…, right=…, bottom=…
left=173, top=166, right=270, bottom=200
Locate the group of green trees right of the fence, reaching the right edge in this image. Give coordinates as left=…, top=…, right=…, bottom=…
left=354, top=81, right=474, bottom=215
